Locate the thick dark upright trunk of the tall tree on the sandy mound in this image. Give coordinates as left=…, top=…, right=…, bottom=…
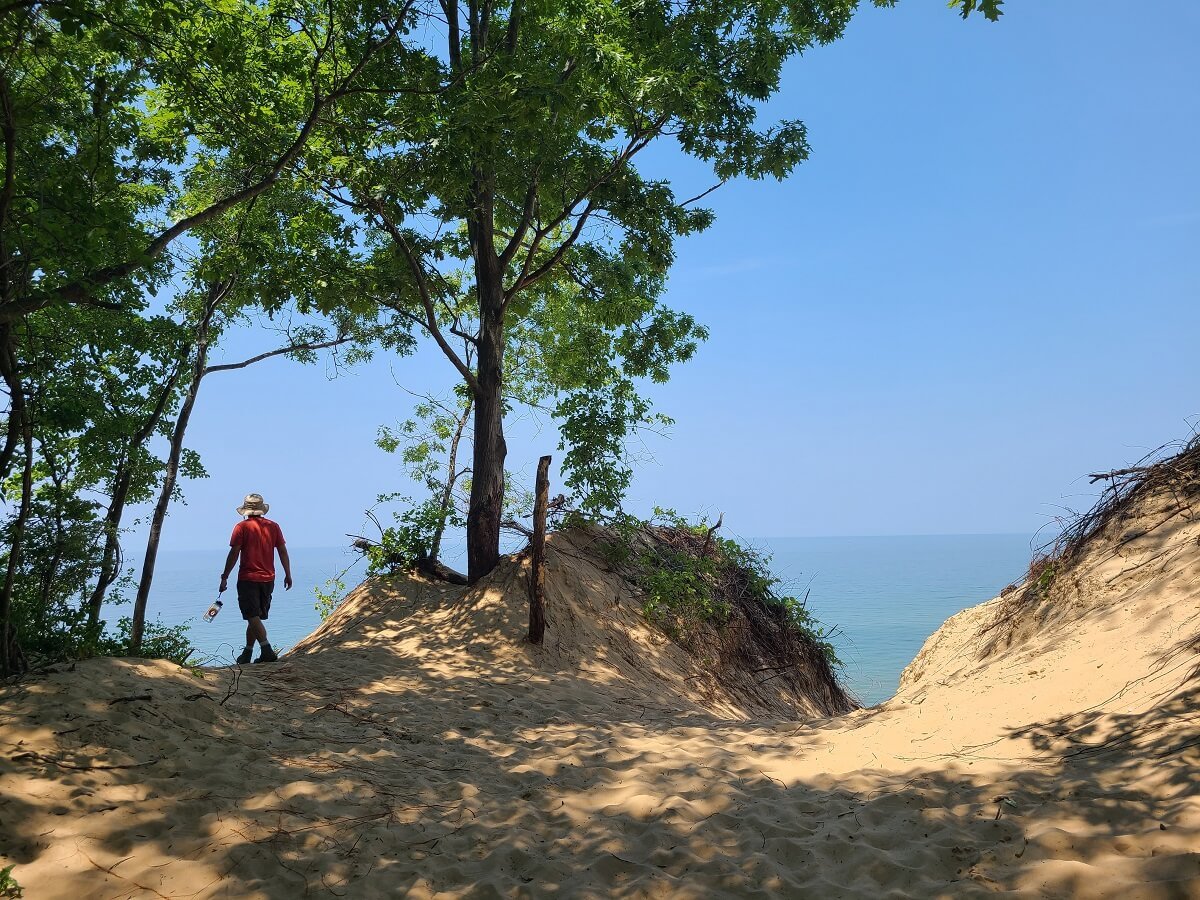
left=467, top=224, right=508, bottom=582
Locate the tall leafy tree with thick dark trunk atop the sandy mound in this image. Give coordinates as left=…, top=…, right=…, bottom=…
left=319, top=0, right=998, bottom=580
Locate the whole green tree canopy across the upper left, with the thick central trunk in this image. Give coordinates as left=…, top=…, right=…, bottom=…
left=0, top=0, right=1001, bottom=671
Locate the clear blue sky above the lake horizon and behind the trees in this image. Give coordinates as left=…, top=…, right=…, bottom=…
left=145, top=0, right=1200, bottom=554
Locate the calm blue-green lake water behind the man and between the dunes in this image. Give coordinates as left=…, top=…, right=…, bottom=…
left=126, top=534, right=1030, bottom=704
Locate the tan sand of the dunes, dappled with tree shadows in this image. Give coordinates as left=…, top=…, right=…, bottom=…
left=0, top=496, right=1200, bottom=900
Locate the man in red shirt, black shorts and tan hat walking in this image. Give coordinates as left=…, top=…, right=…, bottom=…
left=218, top=493, right=292, bottom=666
